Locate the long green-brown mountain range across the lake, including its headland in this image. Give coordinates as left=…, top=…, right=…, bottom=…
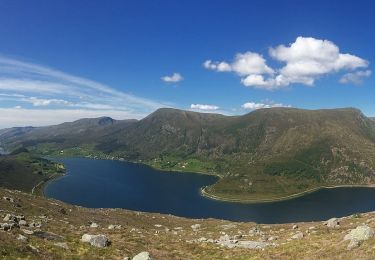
left=0, top=108, right=375, bottom=200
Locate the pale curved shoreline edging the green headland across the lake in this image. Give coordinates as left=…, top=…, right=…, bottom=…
left=200, top=184, right=375, bottom=204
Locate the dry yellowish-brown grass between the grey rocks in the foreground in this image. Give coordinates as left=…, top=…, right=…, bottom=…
left=0, top=188, right=375, bottom=260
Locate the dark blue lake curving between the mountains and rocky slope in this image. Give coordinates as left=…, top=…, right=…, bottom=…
left=44, top=158, right=375, bottom=223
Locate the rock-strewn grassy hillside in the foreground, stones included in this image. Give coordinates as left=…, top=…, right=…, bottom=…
left=0, top=189, right=375, bottom=260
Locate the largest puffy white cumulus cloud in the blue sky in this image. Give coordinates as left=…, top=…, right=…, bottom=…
left=203, top=37, right=369, bottom=90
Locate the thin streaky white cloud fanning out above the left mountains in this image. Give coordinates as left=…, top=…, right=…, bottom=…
left=0, top=56, right=167, bottom=126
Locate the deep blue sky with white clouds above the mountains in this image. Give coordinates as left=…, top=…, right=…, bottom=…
left=0, top=0, right=375, bottom=128
